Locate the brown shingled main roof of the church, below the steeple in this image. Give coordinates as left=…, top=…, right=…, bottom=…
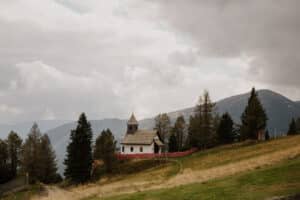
left=121, top=130, right=163, bottom=146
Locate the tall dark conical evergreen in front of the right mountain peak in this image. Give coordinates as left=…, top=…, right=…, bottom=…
left=240, top=88, right=268, bottom=140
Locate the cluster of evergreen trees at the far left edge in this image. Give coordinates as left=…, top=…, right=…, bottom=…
left=0, top=123, right=61, bottom=183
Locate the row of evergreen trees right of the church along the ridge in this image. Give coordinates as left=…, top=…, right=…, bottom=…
left=155, top=88, right=270, bottom=152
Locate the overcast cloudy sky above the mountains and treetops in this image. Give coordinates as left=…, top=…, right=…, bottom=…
left=0, top=0, right=300, bottom=123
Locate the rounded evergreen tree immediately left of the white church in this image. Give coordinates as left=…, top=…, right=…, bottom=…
left=94, top=129, right=116, bottom=173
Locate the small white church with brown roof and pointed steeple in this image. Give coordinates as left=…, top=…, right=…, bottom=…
left=121, top=114, right=164, bottom=154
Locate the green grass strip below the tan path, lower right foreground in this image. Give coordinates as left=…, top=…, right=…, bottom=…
left=89, top=158, right=300, bottom=200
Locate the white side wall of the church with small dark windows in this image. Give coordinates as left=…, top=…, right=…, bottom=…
left=121, top=143, right=154, bottom=154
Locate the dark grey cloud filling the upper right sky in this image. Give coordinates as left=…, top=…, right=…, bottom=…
left=155, top=0, right=300, bottom=87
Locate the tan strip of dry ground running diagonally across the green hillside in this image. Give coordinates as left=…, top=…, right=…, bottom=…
left=34, top=146, right=300, bottom=200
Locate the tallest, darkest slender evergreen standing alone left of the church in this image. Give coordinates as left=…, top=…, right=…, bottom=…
left=64, top=113, right=93, bottom=183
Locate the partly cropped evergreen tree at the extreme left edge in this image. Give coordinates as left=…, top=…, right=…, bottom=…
left=0, top=139, right=11, bottom=184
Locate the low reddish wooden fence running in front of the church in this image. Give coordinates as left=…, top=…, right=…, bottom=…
left=117, top=148, right=197, bottom=160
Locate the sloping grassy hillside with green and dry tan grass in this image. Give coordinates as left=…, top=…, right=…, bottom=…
left=2, top=136, right=300, bottom=200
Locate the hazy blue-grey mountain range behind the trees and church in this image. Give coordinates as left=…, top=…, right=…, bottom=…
left=0, top=90, right=300, bottom=172
